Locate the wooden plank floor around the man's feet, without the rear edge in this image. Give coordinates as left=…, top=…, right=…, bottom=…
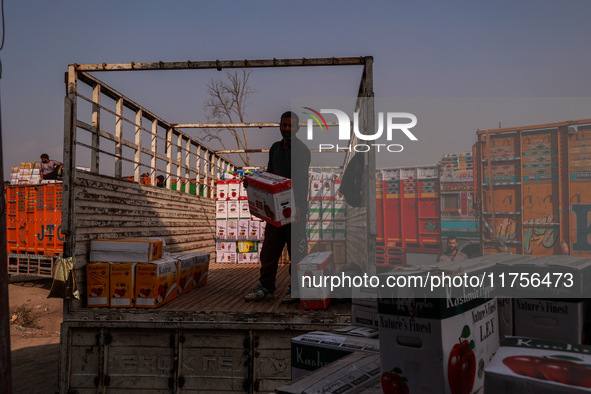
left=157, top=263, right=351, bottom=315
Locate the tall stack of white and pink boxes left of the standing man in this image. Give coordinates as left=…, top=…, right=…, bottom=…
left=215, top=171, right=266, bottom=263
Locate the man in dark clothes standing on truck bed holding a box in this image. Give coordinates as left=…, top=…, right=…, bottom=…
left=244, top=111, right=311, bottom=302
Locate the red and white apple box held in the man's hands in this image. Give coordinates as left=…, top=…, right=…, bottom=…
left=246, top=172, right=295, bottom=227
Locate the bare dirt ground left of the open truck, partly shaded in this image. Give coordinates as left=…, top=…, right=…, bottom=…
left=8, top=278, right=63, bottom=394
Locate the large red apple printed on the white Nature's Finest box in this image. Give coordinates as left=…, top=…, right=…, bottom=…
left=447, top=326, right=476, bottom=394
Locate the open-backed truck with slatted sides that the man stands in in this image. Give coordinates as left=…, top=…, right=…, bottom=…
left=59, top=57, right=376, bottom=393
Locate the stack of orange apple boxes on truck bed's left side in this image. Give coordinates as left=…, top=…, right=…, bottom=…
left=86, top=238, right=209, bottom=308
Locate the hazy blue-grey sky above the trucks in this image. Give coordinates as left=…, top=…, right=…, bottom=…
left=0, top=0, right=591, bottom=177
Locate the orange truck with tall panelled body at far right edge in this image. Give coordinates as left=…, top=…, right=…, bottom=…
left=474, top=119, right=591, bottom=257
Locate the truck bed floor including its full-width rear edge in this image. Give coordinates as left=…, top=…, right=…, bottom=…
left=71, top=263, right=351, bottom=328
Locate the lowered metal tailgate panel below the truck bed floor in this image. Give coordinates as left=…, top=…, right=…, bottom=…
left=62, top=323, right=314, bottom=394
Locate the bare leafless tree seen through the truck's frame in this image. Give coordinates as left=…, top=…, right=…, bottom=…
left=202, top=70, right=255, bottom=166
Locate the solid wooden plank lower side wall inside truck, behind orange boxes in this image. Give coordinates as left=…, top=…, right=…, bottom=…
left=65, top=171, right=215, bottom=312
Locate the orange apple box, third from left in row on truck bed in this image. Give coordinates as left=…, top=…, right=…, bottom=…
left=135, top=257, right=178, bottom=308
